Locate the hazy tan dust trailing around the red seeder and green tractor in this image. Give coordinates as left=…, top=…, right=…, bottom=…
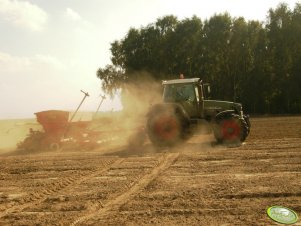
left=0, top=72, right=216, bottom=154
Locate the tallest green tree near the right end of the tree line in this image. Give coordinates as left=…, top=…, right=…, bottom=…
left=267, top=3, right=295, bottom=113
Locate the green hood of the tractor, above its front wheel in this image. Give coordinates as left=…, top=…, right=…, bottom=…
left=204, top=100, right=242, bottom=114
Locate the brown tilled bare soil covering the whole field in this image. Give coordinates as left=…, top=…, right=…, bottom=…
left=0, top=117, right=301, bottom=225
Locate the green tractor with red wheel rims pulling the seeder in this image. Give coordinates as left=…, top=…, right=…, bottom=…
left=146, top=78, right=251, bottom=147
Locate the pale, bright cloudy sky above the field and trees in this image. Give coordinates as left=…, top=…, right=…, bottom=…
left=0, top=0, right=300, bottom=119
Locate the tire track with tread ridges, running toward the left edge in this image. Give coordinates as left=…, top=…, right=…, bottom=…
left=0, top=158, right=124, bottom=219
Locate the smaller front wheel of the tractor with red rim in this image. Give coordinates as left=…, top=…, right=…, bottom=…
left=214, top=114, right=249, bottom=144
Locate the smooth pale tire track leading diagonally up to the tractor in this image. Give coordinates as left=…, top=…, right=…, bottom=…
left=71, top=153, right=180, bottom=226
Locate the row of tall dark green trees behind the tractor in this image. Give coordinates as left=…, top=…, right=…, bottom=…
left=97, top=3, right=301, bottom=114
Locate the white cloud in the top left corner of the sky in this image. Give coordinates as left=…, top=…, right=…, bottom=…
left=0, top=0, right=48, bottom=31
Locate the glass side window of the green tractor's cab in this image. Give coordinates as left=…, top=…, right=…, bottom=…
left=163, top=83, right=196, bottom=102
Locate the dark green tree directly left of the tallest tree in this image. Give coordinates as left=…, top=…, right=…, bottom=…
left=238, top=21, right=271, bottom=113
